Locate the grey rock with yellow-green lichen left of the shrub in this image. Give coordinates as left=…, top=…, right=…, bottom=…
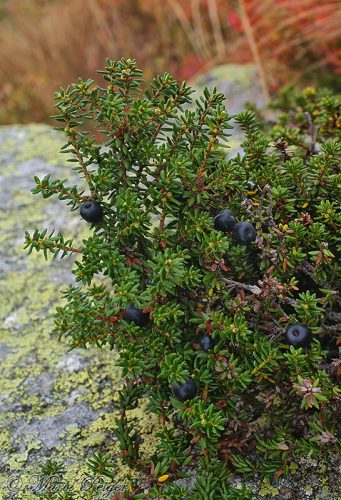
left=0, top=125, right=159, bottom=500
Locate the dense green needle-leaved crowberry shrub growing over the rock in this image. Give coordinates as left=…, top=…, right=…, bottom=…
left=25, top=60, right=341, bottom=499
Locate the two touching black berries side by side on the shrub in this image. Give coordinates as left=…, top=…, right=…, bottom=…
left=214, top=208, right=257, bottom=245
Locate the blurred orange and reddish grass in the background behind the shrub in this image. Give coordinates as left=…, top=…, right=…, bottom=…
left=0, top=0, right=341, bottom=124
